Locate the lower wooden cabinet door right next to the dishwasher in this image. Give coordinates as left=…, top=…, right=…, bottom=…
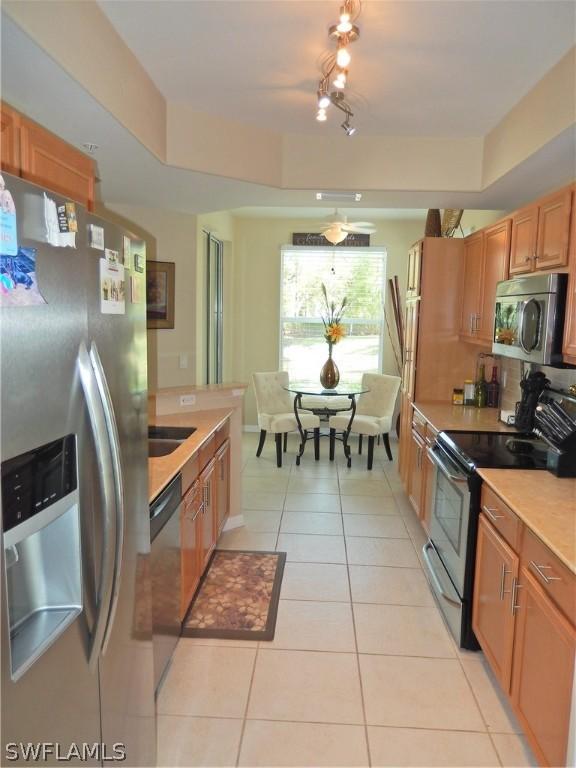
left=180, top=480, right=204, bottom=620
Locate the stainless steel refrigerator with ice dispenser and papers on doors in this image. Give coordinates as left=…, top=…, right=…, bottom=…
left=0, top=174, right=156, bottom=766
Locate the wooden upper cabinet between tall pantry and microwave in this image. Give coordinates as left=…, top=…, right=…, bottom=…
left=460, top=219, right=511, bottom=345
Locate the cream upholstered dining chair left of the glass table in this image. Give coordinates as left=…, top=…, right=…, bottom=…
left=252, top=371, right=320, bottom=467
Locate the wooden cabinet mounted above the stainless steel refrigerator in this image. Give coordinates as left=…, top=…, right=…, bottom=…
left=1, top=104, right=95, bottom=211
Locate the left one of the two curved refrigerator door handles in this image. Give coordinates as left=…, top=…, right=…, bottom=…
left=78, top=342, right=116, bottom=671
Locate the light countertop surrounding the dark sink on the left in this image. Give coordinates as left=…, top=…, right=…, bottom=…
left=148, top=408, right=232, bottom=501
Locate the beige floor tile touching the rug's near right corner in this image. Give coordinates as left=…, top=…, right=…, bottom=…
left=268, top=600, right=356, bottom=653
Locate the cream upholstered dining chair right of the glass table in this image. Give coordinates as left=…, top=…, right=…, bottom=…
left=328, top=373, right=400, bottom=469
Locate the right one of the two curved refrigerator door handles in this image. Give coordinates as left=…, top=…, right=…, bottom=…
left=90, top=341, right=124, bottom=654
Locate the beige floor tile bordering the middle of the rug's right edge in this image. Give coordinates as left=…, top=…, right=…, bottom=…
left=280, top=563, right=350, bottom=602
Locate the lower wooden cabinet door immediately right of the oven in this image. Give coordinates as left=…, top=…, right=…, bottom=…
left=472, top=514, right=520, bottom=691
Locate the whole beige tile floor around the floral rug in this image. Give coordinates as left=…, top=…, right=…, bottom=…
left=158, top=433, right=535, bottom=767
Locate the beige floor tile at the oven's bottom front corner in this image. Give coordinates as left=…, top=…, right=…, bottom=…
left=354, top=604, right=456, bottom=659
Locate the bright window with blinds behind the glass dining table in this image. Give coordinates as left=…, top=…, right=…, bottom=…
left=280, top=246, right=386, bottom=383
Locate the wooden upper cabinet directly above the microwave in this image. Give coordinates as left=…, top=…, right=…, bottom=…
left=510, top=188, right=572, bottom=275
